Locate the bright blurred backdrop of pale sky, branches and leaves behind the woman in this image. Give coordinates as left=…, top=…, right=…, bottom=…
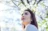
left=0, top=0, right=48, bottom=31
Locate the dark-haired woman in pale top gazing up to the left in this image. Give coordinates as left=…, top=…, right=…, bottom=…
left=22, top=9, right=38, bottom=31
